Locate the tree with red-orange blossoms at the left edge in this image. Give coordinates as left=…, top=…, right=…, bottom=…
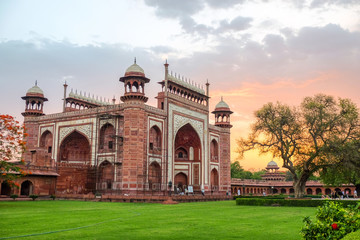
left=0, top=115, right=27, bottom=186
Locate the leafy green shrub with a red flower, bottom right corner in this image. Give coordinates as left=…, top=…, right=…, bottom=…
left=301, top=201, right=360, bottom=240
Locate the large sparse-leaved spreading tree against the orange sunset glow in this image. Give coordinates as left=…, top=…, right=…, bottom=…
left=237, top=94, right=359, bottom=198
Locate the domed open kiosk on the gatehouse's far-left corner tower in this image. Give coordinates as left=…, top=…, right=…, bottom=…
left=21, top=81, right=48, bottom=117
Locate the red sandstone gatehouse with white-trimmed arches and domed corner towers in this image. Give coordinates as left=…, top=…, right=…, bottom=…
left=3, top=62, right=232, bottom=198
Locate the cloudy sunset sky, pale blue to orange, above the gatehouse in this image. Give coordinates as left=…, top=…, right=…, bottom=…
left=0, top=0, right=360, bottom=170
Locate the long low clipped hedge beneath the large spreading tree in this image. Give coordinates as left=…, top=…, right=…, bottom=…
left=236, top=198, right=359, bottom=207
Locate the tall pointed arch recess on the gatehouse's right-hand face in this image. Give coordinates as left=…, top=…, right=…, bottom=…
left=174, top=123, right=202, bottom=190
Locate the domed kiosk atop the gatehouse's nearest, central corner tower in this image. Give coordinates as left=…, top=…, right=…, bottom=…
left=119, top=58, right=150, bottom=103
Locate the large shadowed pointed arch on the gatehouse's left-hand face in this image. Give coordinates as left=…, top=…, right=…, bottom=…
left=60, top=131, right=90, bottom=165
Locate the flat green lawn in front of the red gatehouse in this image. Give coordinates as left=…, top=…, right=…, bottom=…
left=0, top=201, right=316, bottom=240
